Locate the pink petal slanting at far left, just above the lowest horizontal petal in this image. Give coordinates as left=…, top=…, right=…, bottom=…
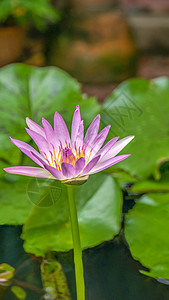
left=10, top=137, right=44, bottom=167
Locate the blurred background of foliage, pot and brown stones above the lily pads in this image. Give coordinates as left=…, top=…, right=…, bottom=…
left=0, top=0, right=169, bottom=101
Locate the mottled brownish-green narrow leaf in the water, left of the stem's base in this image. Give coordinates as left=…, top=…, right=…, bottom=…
left=41, top=258, right=71, bottom=300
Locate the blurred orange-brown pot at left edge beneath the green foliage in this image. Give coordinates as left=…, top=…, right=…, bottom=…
left=0, top=26, right=26, bottom=67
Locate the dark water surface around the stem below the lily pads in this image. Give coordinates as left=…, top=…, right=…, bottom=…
left=0, top=226, right=169, bottom=300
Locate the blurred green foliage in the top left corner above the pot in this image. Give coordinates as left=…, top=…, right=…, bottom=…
left=0, top=0, right=59, bottom=30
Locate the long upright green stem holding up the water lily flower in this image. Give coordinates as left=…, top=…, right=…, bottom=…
left=67, top=185, right=85, bottom=300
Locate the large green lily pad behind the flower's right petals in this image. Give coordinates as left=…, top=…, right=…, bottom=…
left=102, top=78, right=169, bottom=179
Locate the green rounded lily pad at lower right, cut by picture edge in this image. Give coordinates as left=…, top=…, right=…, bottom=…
left=125, top=193, right=169, bottom=279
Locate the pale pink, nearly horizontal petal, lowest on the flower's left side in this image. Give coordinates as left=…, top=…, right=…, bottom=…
left=4, top=166, right=54, bottom=179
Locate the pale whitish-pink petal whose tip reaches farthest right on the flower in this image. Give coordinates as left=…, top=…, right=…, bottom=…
left=101, top=135, right=134, bottom=161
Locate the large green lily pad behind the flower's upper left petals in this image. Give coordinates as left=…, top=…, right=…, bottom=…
left=0, top=64, right=100, bottom=170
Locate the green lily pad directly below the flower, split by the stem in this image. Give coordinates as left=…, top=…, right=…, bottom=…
left=22, top=174, right=122, bottom=256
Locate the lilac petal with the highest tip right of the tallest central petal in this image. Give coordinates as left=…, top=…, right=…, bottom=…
left=84, top=115, right=100, bottom=144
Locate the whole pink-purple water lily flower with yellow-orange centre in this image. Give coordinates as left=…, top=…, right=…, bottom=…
left=4, top=105, right=134, bottom=182
